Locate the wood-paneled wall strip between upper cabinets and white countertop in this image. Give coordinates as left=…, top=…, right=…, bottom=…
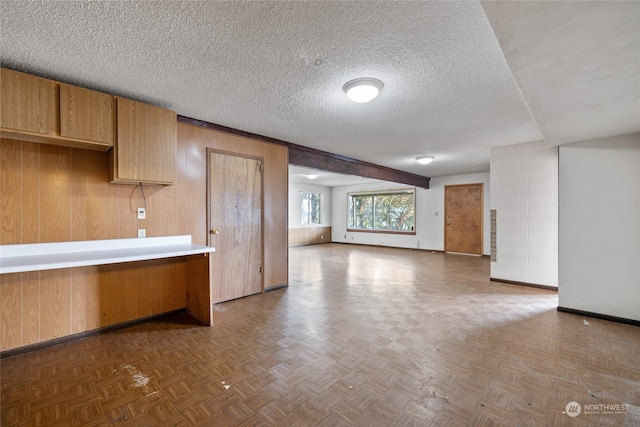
left=0, top=139, right=180, bottom=245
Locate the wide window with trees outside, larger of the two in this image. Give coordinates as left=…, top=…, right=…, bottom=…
left=348, top=189, right=416, bottom=234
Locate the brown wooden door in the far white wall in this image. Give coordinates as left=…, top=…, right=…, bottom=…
left=444, top=184, right=484, bottom=255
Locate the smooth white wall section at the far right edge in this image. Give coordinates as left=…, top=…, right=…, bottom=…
left=558, top=134, right=640, bottom=320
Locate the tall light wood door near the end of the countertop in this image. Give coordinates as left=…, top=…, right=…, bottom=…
left=209, top=151, right=263, bottom=303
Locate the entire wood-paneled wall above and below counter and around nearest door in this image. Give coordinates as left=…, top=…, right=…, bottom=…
left=0, top=124, right=288, bottom=350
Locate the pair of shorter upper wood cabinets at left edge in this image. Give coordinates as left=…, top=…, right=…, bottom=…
left=0, top=68, right=114, bottom=151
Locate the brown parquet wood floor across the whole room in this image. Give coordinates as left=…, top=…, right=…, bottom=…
left=0, top=244, right=640, bottom=427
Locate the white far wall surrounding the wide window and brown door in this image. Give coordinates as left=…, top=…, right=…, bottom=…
left=332, top=173, right=491, bottom=255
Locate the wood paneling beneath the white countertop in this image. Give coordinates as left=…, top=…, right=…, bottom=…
left=0, top=258, right=187, bottom=350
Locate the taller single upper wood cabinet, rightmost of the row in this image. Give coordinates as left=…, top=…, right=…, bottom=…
left=109, top=97, right=177, bottom=185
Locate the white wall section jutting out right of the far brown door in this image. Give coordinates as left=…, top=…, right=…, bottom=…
left=490, top=141, right=558, bottom=286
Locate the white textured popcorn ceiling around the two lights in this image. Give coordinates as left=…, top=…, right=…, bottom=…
left=0, top=0, right=640, bottom=181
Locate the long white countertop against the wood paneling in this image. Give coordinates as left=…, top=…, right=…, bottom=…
left=0, top=235, right=215, bottom=274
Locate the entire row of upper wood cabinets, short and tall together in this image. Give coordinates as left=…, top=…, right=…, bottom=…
left=0, top=68, right=177, bottom=185
